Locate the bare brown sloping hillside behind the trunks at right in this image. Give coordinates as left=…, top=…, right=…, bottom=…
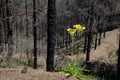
left=80, top=29, right=119, bottom=61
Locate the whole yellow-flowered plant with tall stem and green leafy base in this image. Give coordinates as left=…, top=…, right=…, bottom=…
left=58, top=24, right=93, bottom=79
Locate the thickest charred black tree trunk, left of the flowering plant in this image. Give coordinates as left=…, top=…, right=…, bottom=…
left=46, top=0, right=56, bottom=71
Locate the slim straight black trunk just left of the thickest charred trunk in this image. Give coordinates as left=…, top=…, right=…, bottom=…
left=33, top=0, right=37, bottom=69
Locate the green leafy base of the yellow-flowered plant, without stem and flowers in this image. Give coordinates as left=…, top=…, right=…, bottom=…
left=57, top=58, right=93, bottom=79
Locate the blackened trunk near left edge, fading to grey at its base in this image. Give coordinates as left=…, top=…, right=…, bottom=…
left=1, top=0, right=13, bottom=61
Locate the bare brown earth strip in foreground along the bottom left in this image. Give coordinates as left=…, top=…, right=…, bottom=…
left=0, top=69, right=78, bottom=80
